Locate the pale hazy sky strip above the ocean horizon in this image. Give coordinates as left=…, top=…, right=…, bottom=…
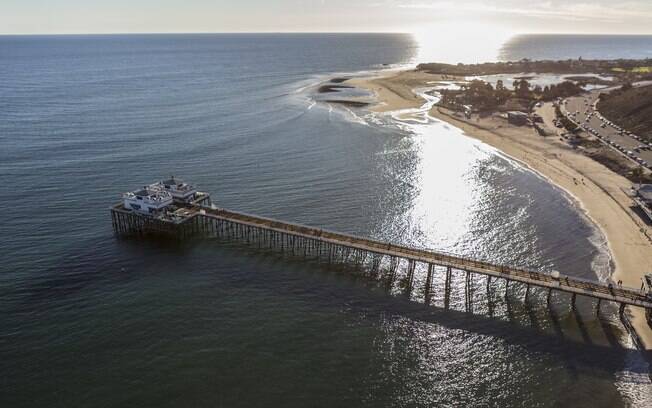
left=0, top=0, right=652, bottom=34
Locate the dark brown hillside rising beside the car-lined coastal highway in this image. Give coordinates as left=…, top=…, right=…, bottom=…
left=598, top=86, right=652, bottom=140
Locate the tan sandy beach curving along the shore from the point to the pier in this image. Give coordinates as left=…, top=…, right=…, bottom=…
left=348, top=71, right=652, bottom=350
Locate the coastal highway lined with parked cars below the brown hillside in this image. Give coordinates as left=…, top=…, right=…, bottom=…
left=561, top=90, right=652, bottom=170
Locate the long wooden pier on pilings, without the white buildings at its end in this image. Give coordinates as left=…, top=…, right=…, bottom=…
left=111, top=200, right=652, bottom=321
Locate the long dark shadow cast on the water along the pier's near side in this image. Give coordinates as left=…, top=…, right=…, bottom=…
left=7, top=238, right=652, bottom=364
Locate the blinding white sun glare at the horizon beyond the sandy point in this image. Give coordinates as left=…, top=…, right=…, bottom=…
left=413, top=23, right=515, bottom=64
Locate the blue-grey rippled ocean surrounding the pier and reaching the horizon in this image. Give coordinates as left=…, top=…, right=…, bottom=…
left=0, top=34, right=652, bottom=408
